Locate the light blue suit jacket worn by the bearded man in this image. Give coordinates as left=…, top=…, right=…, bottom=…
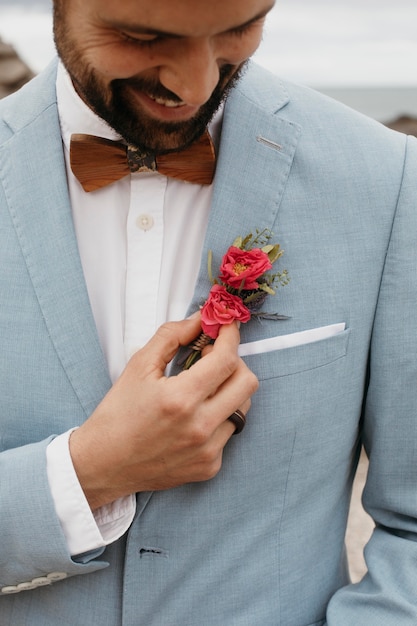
left=0, top=59, right=417, bottom=626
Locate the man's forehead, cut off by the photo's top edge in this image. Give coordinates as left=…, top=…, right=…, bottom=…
left=70, top=0, right=275, bottom=37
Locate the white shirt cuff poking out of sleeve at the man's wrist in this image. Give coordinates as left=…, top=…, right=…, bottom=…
left=46, top=429, right=136, bottom=556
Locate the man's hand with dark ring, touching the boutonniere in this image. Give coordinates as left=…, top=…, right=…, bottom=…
left=70, top=316, right=258, bottom=509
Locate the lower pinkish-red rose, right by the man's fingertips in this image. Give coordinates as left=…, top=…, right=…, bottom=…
left=201, top=285, right=250, bottom=339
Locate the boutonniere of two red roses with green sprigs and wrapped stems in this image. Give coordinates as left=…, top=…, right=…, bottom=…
left=182, top=229, right=289, bottom=369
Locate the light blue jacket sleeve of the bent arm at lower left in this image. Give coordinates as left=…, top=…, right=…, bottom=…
left=0, top=439, right=107, bottom=588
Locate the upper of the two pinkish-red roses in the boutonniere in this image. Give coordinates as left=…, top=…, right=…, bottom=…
left=220, top=246, right=272, bottom=289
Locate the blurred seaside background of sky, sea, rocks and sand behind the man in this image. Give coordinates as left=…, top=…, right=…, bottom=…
left=0, top=0, right=417, bottom=581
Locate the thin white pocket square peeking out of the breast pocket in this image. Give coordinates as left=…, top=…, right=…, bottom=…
left=238, top=322, right=346, bottom=356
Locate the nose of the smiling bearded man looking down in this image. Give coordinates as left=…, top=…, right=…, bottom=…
left=159, top=39, right=219, bottom=106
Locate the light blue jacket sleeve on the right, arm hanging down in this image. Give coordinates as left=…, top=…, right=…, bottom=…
left=327, top=134, right=417, bottom=626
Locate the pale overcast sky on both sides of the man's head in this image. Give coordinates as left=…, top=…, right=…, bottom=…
left=0, top=0, right=417, bottom=87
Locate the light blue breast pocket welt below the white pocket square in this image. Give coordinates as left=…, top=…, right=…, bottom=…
left=243, top=329, right=350, bottom=380
